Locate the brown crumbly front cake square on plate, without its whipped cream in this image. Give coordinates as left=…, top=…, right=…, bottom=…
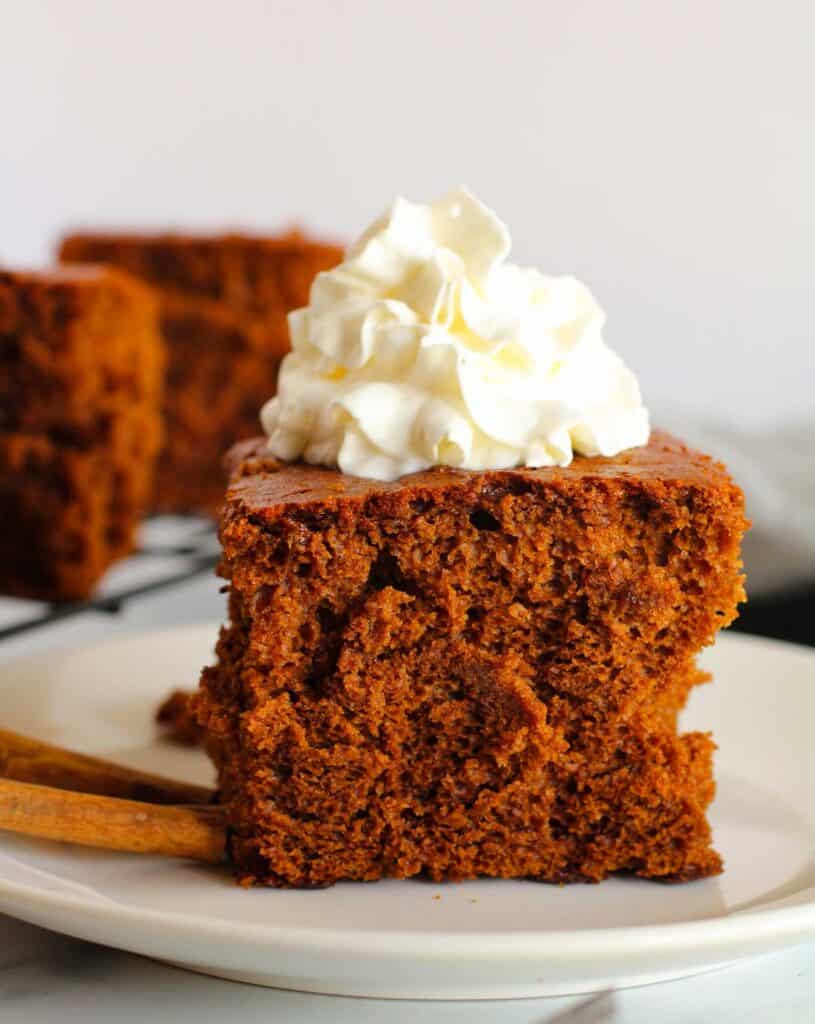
left=197, top=432, right=745, bottom=887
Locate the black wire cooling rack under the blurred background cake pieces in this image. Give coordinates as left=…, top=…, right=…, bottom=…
left=0, top=517, right=219, bottom=641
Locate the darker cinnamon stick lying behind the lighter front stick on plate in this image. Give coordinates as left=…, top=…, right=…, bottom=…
left=0, top=729, right=213, bottom=804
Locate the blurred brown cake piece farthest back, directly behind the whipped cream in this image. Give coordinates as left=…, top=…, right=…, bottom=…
left=59, top=232, right=342, bottom=513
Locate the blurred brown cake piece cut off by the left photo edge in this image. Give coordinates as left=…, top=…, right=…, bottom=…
left=0, top=266, right=164, bottom=600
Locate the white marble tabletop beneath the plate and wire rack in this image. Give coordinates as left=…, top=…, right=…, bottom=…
left=0, top=526, right=815, bottom=1024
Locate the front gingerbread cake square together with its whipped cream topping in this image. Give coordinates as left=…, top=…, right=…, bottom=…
left=196, top=189, right=746, bottom=886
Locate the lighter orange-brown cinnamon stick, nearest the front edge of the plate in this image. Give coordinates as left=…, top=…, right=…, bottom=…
left=0, top=779, right=226, bottom=863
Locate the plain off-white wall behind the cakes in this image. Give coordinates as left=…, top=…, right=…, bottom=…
left=0, top=0, right=815, bottom=427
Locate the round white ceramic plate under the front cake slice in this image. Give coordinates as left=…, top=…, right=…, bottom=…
left=0, top=625, right=815, bottom=998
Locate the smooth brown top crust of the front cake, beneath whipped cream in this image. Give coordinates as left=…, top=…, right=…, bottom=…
left=226, top=430, right=733, bottom=514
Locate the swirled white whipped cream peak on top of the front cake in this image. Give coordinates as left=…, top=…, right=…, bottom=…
left=261, top=188, right=649, bottom=480
